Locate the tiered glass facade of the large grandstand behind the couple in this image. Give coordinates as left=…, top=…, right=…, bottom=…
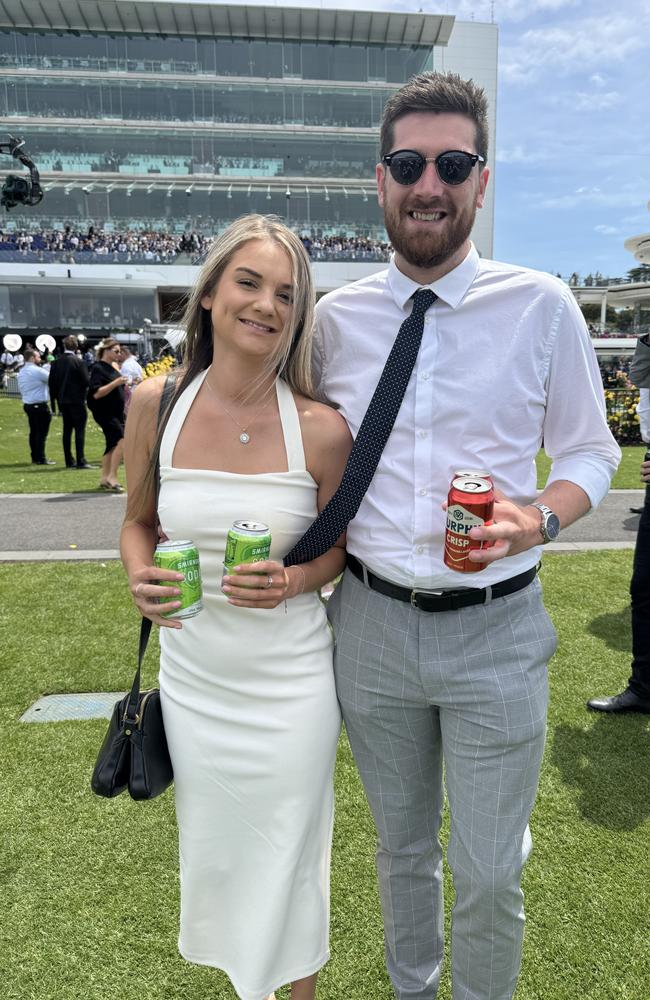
left=0, top=26, right=433, bottom=238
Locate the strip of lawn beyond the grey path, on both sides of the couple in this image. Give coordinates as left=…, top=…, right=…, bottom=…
left=0, top=398, right=645, bottom=493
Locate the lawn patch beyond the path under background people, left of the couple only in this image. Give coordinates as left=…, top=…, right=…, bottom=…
left=0, top=397, right=126, bottom=493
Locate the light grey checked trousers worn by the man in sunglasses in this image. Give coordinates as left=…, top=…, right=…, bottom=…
left=328, top=571, right=556, bottom=1000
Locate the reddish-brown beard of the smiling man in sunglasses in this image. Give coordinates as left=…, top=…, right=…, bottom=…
left=384, top=204, right=476, bottom=270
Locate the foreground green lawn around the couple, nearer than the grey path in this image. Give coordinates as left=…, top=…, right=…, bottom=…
left=0, top=552, right=650, bottom=1000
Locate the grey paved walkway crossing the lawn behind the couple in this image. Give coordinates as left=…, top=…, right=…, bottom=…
left=0, top=489, right=644, bottom=562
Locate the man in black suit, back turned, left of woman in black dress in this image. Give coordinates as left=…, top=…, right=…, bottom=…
left=49, top=336, right=96, bottom=469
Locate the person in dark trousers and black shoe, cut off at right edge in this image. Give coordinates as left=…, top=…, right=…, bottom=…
left=587, top=335, right=650, bottom=715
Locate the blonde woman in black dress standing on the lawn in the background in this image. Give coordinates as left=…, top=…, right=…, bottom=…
left=88, top=337, right=127, bottom=493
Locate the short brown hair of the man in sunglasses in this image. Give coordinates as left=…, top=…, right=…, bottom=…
left=379, top=73, right=488, bottom=160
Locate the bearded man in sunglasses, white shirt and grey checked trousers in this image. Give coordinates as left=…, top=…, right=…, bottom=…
left=315, top=73, right=620, bottom=1000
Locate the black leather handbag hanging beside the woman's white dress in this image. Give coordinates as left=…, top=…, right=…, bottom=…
left=91, top=618, right=174, bottom=799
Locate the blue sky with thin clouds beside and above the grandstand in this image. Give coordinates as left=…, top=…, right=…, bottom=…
left=197, top=0, right=650, bottom=277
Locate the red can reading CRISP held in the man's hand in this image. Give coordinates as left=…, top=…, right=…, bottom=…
left=444, top=476, right=494, bottom=573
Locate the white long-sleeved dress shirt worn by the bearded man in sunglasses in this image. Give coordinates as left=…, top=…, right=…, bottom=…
left=314, top=246, right=621, bottom=590
